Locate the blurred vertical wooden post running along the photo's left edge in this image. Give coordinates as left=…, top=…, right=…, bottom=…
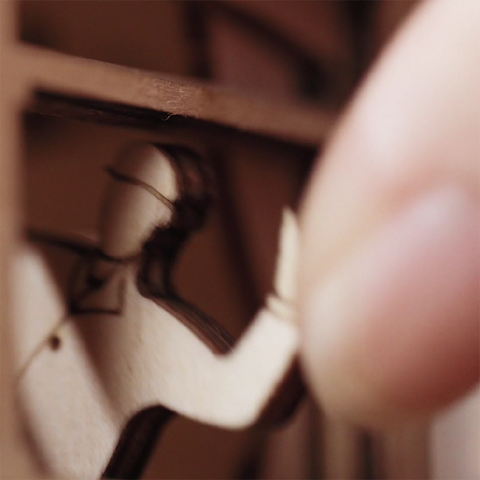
left=0, top=5, right=45, bottom=474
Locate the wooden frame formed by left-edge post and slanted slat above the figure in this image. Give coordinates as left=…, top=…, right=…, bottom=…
left=0, top=2, right=334, bottom=478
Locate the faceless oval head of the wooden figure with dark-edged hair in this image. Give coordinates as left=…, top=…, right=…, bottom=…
left=99, top=143, right=210, bottom=258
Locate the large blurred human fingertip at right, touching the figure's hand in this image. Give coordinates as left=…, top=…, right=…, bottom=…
left=299, top=0, right=480, bottom=426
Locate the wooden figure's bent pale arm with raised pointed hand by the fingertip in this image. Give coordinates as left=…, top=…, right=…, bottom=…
left=139, top=213, right=298, bottom=428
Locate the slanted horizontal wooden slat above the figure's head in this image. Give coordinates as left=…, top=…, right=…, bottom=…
left=8, top=45, right=335, bottom=145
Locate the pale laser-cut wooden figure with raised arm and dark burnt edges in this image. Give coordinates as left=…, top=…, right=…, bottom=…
left=16, top=143, right=301, bottom=480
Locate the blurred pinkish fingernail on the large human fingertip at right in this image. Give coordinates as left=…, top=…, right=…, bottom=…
left=301, top=186, right=480, bottom=425
